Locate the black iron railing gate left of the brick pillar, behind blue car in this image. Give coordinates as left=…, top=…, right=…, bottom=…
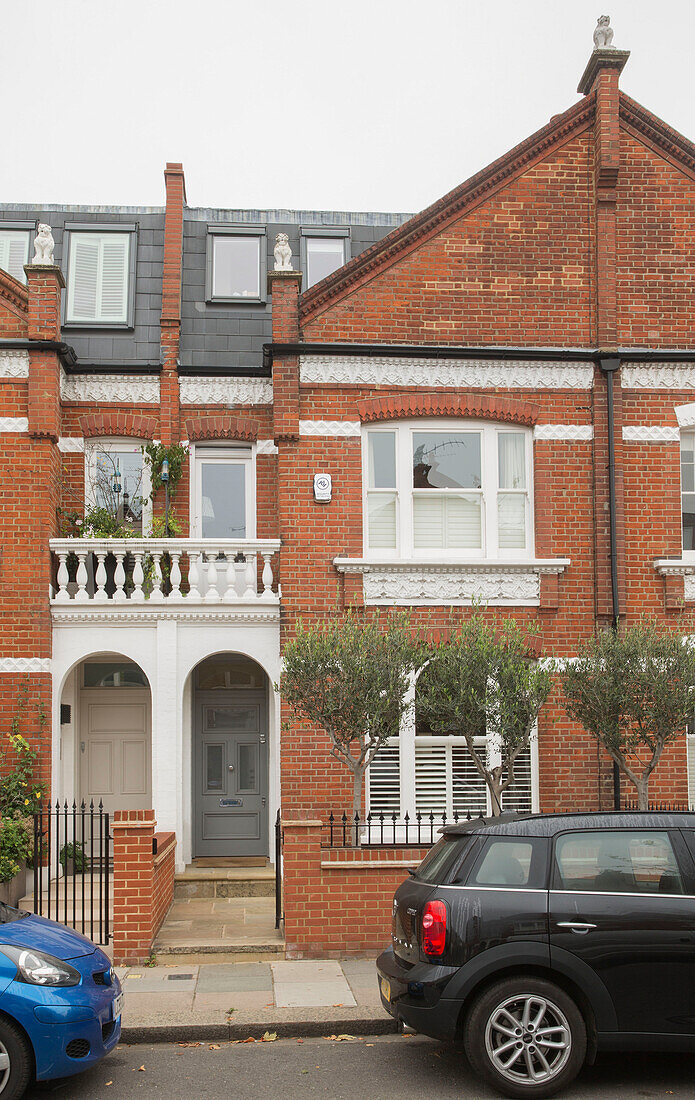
left=33, top=801, right=112, bottom=944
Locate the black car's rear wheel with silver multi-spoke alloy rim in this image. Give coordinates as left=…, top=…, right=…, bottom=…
left=464, top=978, right=586, bottom=1100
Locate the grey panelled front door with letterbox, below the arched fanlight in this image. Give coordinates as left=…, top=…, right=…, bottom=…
left=194, top=691, right=268, bottom=857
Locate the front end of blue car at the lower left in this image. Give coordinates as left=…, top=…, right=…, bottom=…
left=0, top=902, right=123, bottom=1100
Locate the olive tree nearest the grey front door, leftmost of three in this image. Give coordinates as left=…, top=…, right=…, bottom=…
left=279, top=614, right=419, bottom=814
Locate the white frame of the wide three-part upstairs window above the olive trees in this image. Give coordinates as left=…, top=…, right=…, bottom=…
left=362, top=418, right=534, bottom=561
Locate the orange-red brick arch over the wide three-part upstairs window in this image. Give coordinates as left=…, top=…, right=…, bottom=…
left=357, top=391, right=539, bottom=427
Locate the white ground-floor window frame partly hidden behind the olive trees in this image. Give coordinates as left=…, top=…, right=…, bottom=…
left=365, top=670, right=539, bottom=837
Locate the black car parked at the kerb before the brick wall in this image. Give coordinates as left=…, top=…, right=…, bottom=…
left=377, top=813, right=695, bottom=1097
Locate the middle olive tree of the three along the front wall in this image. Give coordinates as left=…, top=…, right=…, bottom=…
left=417, top=614, right=552, bottom=816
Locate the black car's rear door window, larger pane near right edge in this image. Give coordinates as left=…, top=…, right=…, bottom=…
left=554, top=829, right=685, bottom=894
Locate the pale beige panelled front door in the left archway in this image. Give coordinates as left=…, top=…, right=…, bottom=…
left=79, top=688, right=152, bottom=813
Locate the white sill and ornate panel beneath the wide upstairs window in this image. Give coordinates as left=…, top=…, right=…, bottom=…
left=333, top=558, right=570, bottom=606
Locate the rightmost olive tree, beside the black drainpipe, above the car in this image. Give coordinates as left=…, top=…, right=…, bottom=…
left=561, top=622, right=695, bottom=810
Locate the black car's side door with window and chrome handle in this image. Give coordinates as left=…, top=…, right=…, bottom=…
left=549, top=827, right=695, bottom=1034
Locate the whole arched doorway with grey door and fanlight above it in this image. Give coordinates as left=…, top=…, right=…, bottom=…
left=191, top=653, right=268, bottom=859
